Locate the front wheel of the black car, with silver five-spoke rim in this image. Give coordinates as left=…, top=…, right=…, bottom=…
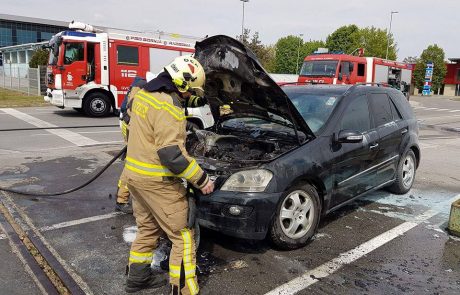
left=270, top=184, right=321, bottom=250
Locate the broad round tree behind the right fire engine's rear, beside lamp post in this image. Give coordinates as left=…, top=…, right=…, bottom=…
left=355, top=27, right=397, bottom=60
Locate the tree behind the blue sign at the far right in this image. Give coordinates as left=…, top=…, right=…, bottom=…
left=414, top=44, right=447, bottom=92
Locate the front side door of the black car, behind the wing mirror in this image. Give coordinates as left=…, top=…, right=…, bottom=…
left=331, top=94, right=379, bottom=206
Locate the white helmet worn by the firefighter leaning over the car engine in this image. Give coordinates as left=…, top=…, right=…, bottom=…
left=165, top=55, right=206, bottom=96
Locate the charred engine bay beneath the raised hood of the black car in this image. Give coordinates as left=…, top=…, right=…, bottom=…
left=186, top=129, right=297, bottom=174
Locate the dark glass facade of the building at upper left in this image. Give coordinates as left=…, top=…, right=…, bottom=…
left=0, top=19, right=67, bottom=47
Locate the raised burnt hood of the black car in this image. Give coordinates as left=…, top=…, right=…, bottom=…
left=195, top=35, right=314, bottom=137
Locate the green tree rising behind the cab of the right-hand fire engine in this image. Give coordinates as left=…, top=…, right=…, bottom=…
left=326, top=25, right=359, bottom=53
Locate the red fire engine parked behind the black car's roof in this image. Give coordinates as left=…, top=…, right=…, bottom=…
left=298, top=49, right=412, bottom=96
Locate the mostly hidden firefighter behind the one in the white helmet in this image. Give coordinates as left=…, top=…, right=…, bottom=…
left=115, top=77, right=146, bottom=214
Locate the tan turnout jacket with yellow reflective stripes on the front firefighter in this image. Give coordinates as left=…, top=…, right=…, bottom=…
left=125, top=89, right=209, bottom=189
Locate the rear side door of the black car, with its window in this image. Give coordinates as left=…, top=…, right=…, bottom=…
left=369, top=92, right=407, bottom=186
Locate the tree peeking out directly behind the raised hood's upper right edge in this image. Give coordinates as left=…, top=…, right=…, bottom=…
left=237, top=29, right=275, bottom=72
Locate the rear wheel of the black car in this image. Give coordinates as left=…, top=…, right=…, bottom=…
left=388, top=150, right=417, bottom=195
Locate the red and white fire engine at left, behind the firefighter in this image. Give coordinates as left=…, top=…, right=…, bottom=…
left=44, top=22, right=212, bottom=127
